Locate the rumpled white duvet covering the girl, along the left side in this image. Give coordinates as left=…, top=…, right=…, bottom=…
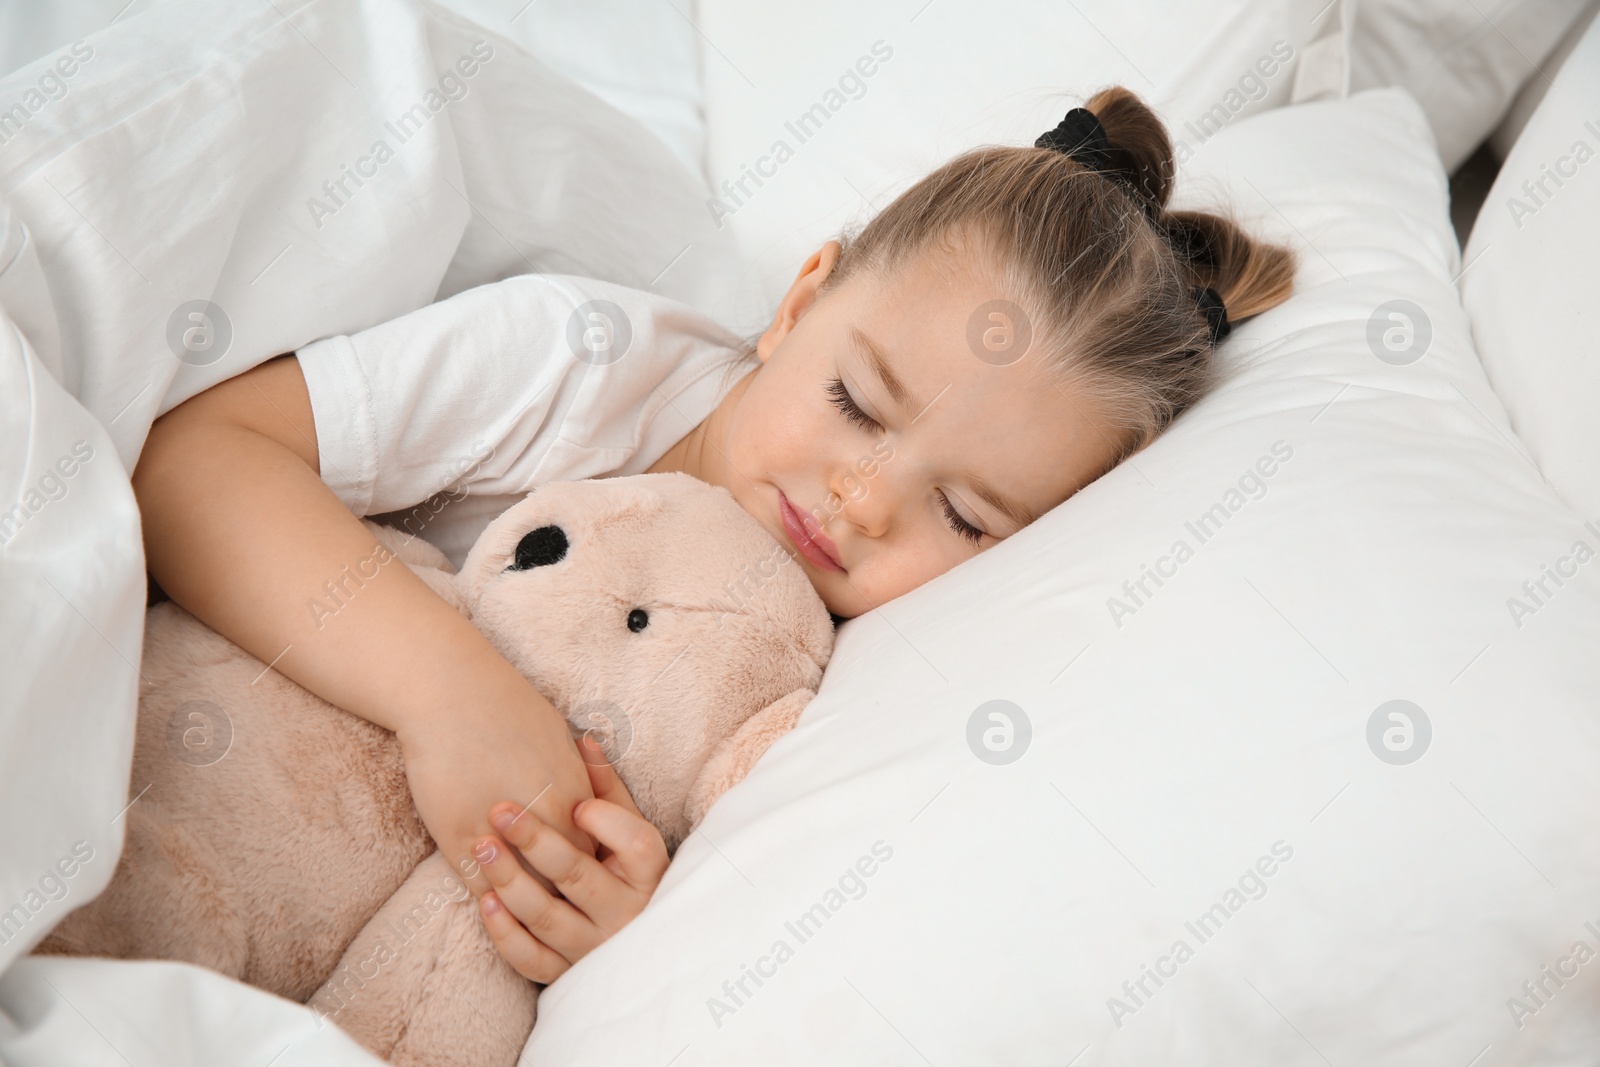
left=0, top=0, right=738, bottom=1065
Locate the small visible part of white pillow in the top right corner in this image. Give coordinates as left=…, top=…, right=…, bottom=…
left=1350, top=0, right=1590, bottom=173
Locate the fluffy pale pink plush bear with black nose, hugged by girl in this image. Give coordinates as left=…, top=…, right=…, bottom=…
left=40, top=474, right=834, bottom=1067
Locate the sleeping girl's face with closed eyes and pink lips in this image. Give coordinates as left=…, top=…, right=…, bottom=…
left=675, top=233, right=1115, bottom=617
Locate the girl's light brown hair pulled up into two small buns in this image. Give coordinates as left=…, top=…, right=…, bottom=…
left=713, top=86, right=1294, bottom=469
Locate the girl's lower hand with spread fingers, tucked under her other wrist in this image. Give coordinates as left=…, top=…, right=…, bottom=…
left=474, top=737, right=667, bottom=984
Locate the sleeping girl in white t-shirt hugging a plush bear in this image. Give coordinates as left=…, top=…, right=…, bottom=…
left=133, top=88, right=1293, bottom=982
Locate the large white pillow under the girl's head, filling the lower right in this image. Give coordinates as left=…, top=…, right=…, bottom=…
left=523, top=85, right=1600, bottom=1067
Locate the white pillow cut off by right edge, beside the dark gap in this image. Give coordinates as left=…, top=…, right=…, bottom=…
left=1461, top=11, right=1600, bottom=522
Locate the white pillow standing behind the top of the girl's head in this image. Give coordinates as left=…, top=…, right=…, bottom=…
left=699, top=0, right=1350, bottom=333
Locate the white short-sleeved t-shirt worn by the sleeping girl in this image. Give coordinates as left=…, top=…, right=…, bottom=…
left=294, top=274, right=741, bottom=566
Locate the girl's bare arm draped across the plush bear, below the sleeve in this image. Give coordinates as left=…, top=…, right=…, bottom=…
left=133, top=357, right=594, bottom=894
